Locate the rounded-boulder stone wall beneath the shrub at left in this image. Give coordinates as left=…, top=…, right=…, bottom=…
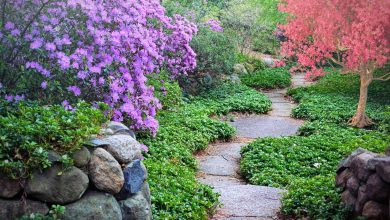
left=0, top=122, right=152, bottom=220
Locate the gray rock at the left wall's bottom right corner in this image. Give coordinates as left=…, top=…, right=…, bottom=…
left=119, top=193, right=152, bottom=220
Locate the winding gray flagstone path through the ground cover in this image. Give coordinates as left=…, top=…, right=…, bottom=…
left=197, top=74, right=309, bottom=220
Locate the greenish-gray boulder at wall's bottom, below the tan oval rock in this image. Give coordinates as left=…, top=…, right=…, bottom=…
left=62, top=191, right=122, bottom=220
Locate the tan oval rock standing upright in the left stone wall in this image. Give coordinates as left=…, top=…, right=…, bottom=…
left=89, top=148, right=124, bottom=194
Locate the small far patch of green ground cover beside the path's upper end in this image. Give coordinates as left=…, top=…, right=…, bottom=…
left=240, top=67, right=291, bottom=89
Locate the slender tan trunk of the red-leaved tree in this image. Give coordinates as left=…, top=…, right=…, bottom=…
left=349, top=70, right=373, bottom=128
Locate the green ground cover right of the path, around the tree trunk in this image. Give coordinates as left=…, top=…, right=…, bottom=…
left=241, top=72, right=390, bottom=219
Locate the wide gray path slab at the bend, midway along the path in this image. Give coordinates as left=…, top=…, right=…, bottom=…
left=231, top=115, right=303, bottom=138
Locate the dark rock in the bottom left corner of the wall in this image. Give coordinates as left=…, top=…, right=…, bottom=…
left=0, top=199, right=49, bottom=220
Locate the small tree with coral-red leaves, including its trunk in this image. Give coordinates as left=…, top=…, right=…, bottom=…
left=280, top=0, right=390, bottom=127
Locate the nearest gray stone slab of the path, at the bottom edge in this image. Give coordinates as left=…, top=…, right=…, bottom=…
left=215, top=185, right=283, bottom=219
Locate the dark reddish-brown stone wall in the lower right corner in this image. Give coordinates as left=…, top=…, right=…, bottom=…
left=336, top=148, right=390, bottom=219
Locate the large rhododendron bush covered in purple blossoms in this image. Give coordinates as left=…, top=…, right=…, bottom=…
left=0, top=0, right=197, bottom=132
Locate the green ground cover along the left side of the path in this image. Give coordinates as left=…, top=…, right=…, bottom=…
left=139, top=84, right=271, bottom=219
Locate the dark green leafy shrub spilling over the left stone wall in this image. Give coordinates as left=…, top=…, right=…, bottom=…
left=0, top=102, right=107, bottom=177
